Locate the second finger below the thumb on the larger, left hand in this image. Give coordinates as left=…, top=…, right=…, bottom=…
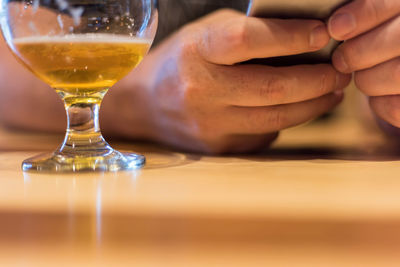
left=221, top=93, right=343, bottom=134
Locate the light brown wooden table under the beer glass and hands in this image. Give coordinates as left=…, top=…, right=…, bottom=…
left=0, top=101, right=400, bottom=266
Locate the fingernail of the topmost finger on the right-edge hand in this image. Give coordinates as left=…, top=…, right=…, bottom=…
left=328, top=13, right=357, bottom=40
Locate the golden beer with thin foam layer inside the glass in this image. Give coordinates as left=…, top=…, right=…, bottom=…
left=13, top=34, right=150, bottom=95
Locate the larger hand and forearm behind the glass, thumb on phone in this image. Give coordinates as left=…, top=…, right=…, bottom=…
left=0, top=10, right=350, bottom=154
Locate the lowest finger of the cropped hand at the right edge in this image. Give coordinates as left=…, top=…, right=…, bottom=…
left=370, top=95, right=400, bottom=127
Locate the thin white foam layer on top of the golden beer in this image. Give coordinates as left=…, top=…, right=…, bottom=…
left=12, top=33, right=152, bottom=45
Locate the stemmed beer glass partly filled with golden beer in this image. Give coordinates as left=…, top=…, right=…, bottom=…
left=0, top=0, right=158, bottom=172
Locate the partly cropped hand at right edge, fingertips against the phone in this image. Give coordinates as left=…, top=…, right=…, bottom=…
left=328, top=0, right=400, bottom=130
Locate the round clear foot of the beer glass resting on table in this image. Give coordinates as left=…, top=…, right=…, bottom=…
left=22, top=150, right=145, bottom=172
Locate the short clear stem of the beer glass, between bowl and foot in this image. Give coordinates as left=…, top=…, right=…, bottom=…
left=58, top=89, right=112, bottom=156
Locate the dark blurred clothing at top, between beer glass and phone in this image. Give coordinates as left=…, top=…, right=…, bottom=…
left=155, top=0, right=249, bottom=44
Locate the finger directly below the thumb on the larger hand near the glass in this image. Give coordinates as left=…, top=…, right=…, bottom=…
left=210, top=65, right=351, bottom=107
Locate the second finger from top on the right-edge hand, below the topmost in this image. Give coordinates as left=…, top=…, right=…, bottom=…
left=332, top=16, right=400, bottom=73
